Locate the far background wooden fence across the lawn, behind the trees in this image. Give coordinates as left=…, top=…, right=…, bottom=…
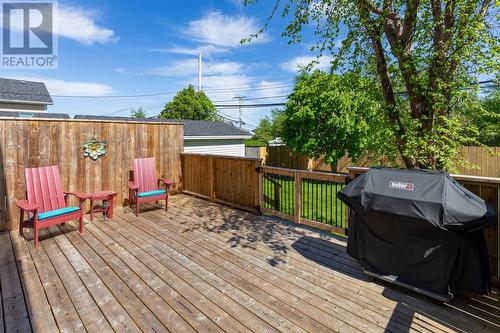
left=260, top=146, right=500, bottom=177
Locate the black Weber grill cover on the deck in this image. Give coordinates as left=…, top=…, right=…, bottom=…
left=338, top=168, right=496, bottom=294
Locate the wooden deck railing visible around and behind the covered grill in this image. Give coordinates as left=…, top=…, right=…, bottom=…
left=349, top=167, right=500, bottom=284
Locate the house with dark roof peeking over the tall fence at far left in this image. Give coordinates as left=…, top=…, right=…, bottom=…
left=0, top=78, right=52, bottom=118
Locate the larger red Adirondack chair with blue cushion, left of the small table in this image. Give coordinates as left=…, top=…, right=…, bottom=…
left=17, top=165, right=87, bottom=248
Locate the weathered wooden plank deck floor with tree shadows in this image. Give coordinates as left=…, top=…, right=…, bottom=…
left=0, top=195, right=500, bottom=333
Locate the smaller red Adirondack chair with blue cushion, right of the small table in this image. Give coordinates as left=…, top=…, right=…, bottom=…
left=128, top=158, right=174, bottom=216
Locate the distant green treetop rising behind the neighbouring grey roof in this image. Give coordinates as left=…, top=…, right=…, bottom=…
left=159, top=85, right=221, bottom=121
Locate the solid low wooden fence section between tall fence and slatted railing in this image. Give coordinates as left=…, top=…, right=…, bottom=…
left=181, top=153, right=261, bottom=213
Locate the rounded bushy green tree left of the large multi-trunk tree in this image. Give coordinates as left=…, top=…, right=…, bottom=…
left=282, top=71, right=387, bottom=170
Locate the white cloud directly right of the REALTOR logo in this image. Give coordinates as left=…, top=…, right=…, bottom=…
left=57, top=6, right=118, bottom=45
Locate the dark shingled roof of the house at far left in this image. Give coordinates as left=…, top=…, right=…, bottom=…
left=0, top=78, right=52, bottom=105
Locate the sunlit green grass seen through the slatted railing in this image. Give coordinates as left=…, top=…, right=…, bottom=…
left=264, top=175, right=346, bottom=228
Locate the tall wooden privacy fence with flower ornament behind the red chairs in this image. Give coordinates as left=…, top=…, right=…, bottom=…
left=0, top=118, right=183, bottom=231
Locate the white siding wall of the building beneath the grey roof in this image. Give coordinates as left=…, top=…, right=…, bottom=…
left=184, top=139, right=245, bottom=157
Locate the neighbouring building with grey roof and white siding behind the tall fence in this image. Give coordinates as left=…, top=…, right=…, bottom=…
left=75, top=115, right=252, bottom=157
